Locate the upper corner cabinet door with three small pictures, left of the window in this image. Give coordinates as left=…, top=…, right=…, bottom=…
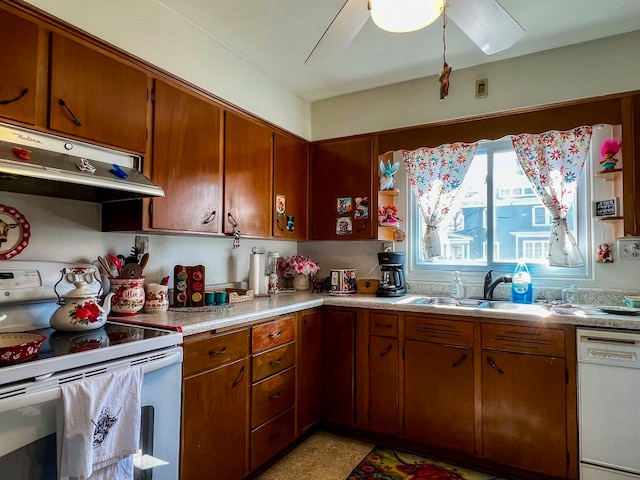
left=311, top=137, right=378, bottom=240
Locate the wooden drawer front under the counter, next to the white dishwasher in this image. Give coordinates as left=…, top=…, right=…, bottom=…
left=482, top=324, right=565, bottom=357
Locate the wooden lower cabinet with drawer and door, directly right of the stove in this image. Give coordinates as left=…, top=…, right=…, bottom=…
left=180, top=330, right=249, bottom=480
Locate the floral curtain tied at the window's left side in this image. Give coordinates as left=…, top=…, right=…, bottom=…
left=402, top=142, right=478, bottom=259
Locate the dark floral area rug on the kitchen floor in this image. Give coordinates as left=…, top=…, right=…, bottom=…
left=347, top=447, right=506, bottom=480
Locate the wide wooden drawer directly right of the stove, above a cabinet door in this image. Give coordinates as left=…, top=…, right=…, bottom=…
left=182, top=329, right=249, bottom=375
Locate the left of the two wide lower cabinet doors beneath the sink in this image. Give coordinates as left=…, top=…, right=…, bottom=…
left=404, top=340, right=474, bottom=454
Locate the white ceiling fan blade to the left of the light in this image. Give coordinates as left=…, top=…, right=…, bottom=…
left=304, top=0, right=370, bottom=67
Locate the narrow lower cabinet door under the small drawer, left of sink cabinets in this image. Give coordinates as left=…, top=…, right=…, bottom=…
left=369, top=336, right=400, bottom=436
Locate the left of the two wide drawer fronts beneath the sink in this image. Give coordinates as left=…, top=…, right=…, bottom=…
left=404, top=315, right=473, bottom=347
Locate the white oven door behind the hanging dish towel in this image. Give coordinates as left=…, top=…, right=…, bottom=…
left=0, top=347, right=182, bottom=480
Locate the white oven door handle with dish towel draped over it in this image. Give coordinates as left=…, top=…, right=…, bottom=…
left=0, top=348, right=182, bottom=413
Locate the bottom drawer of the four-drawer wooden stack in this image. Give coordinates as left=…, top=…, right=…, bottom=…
left=251, top=408, right=295, bottom=470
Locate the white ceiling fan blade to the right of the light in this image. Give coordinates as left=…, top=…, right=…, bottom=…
left=446, top=0, right=525, bottom=55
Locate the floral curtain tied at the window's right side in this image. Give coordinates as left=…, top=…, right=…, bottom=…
left=511, top=126, right=592, bottom=268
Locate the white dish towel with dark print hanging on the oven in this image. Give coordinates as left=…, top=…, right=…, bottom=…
left=60, top=367, right=143, bottom=480
